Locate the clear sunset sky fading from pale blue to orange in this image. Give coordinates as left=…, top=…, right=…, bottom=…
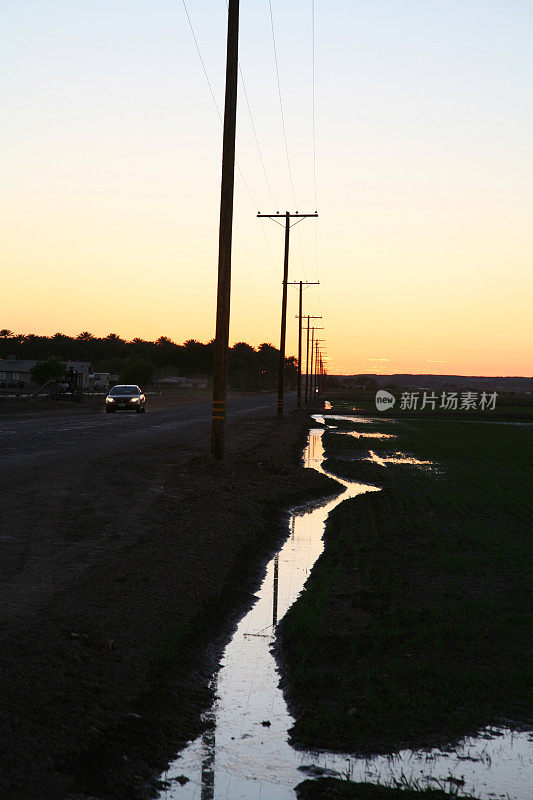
left=0, top=0, right=533, bottom=376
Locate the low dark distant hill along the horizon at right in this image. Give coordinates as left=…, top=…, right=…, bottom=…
left=335, top=372, right=533, bottom=393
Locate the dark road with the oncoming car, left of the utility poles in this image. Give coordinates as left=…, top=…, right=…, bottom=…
left=0, top=395, right=294, bottom=632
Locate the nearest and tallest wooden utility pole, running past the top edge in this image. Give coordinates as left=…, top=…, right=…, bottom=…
left=211, top=0, right=239, bottom=460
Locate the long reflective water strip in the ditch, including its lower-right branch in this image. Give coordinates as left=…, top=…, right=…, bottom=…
left=159, top=417, right=533, bottom=800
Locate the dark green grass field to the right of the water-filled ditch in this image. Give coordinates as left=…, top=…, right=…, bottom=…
left=278, top=412, right=533, bottom=753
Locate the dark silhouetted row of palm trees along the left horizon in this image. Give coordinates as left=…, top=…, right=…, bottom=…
left=0, top=328, right=297, bottom=389
